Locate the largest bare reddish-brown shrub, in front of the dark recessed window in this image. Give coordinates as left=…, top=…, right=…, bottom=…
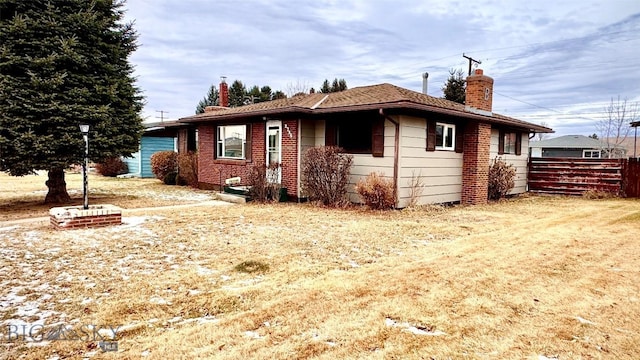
left=301, top=146, right=353, bottom=206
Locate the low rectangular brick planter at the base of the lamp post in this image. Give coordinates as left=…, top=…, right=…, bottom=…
left=49, top=205, right=122, bottom=230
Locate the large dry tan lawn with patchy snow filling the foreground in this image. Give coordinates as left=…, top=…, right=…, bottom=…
left=0, top=176, right=640, bottom=359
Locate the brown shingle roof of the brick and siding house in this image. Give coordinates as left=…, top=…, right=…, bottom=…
left=180, top=83, right=553, bottom=132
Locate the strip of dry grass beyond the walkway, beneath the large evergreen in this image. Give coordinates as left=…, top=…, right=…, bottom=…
left=0, top=172, right=218, bottom=221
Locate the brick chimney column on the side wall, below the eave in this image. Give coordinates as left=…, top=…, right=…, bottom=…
left=461, top=122, right=491, bottom=205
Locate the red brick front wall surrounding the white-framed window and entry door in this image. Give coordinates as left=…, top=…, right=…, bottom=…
left=198, top=120, right=298, bottom=197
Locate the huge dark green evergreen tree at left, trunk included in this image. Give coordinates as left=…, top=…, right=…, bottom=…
left=0, top=0, right=143, bottom=203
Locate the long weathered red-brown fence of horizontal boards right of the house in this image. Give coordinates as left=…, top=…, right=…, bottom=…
left=528, top=158, right=624, bottom=195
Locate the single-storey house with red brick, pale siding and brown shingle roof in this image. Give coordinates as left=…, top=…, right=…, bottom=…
left=179, top=69, right=552, bottom=207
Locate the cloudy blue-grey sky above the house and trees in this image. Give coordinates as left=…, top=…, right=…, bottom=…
left=125, top=0, right=640, bottom=136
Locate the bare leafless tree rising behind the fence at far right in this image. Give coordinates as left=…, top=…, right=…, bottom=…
left=596, top=96, right=638, bottom=158
